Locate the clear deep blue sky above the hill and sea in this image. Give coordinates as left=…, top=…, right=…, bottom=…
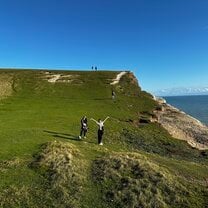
left=0, top=0, right=208, bottom=91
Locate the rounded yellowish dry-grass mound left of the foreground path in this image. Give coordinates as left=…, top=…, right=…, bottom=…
left=32, top=141, right=83, bottom=207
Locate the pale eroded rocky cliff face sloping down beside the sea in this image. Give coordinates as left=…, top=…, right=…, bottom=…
left=154, top=98, right=208, bottom=150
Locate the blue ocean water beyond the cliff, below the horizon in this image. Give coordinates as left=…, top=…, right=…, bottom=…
left=163, top=95, right=208, bottom=125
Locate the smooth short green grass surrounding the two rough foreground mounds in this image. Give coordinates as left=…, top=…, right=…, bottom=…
left=0, top=71, right=208, bottom=207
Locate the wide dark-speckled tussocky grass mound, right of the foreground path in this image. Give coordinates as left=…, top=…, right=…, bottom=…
left=93, top=154, right=192, bottom=208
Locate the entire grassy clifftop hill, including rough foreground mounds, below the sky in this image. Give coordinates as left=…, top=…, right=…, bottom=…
left=0, top=70, right=208, bottom=208
